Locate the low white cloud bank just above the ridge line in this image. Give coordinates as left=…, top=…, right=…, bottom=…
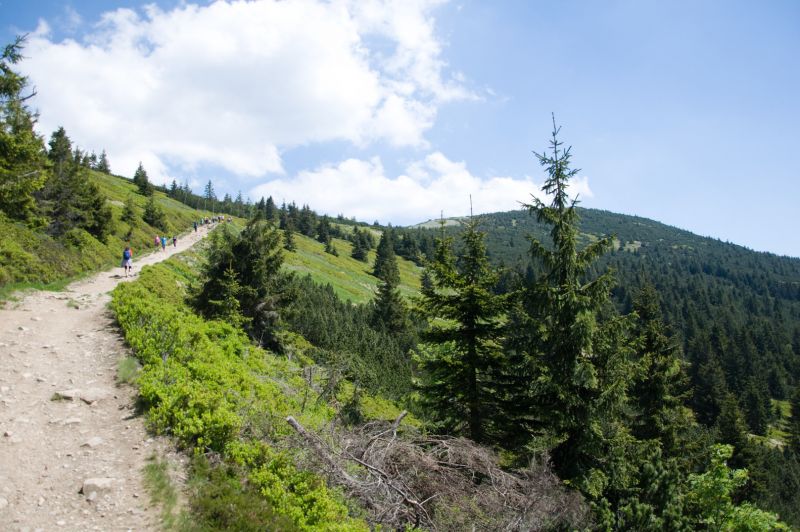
left=250, top=152, right=592, bottom=225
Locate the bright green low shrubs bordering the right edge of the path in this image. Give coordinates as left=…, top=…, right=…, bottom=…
left=111, top=261, right=365, bottom=530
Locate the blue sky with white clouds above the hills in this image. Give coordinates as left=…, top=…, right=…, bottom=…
left=0, top=0, right=800, bottom=257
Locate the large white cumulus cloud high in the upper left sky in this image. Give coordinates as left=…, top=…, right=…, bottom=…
left=21, top=0, right=473, bottom=180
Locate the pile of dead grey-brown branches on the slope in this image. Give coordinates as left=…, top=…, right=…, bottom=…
left=287, top=413, right=589, bottom=531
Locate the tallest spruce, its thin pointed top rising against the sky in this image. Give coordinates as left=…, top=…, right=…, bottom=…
left=507, top=119, right=632, bottom=498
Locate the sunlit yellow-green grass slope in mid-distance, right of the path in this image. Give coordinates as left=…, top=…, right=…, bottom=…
left=286, top=233, right=422, bottom=303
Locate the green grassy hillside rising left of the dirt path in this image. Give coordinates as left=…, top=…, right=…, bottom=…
left=0, top=171, right=216, bottom=299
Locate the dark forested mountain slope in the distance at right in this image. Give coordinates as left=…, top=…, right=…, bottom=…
left=404, top=208, right=800, bottom=420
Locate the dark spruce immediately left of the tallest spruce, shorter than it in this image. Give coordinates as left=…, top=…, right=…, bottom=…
left=418, top=219, right=505, bottom=442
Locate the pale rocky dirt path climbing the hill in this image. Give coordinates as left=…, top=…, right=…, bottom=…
left=0, top=227, right=212, bottom=531
